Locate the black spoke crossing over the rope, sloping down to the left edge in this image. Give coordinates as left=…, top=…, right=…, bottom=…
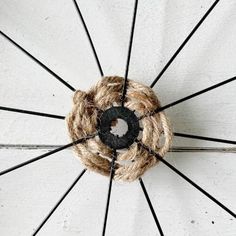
left=0, top=135, right=95, bottom=176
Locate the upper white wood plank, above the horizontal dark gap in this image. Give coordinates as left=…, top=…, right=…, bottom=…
left=0, top=0, right=236, bottom=146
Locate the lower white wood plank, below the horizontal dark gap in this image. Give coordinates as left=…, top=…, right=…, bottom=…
left=0, top=150, right=236, bottom=236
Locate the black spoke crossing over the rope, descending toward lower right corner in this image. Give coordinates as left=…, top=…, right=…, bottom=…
left=137, top=141, right=236, bottom=218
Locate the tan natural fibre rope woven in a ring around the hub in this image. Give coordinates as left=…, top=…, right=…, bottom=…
left=67, top=76, right=172, bottom=181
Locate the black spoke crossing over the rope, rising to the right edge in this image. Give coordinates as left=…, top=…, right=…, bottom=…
left=140, top=76, right=236, bottom=119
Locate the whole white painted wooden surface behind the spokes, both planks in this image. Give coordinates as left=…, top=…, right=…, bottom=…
left=0, top=0, right=236, bottom=236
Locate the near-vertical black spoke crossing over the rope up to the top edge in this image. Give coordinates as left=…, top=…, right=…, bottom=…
left=121, top=0, right=138, bottom=107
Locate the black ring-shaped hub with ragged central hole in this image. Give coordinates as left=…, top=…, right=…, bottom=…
left=98, top=107, right=140, bottom=149
